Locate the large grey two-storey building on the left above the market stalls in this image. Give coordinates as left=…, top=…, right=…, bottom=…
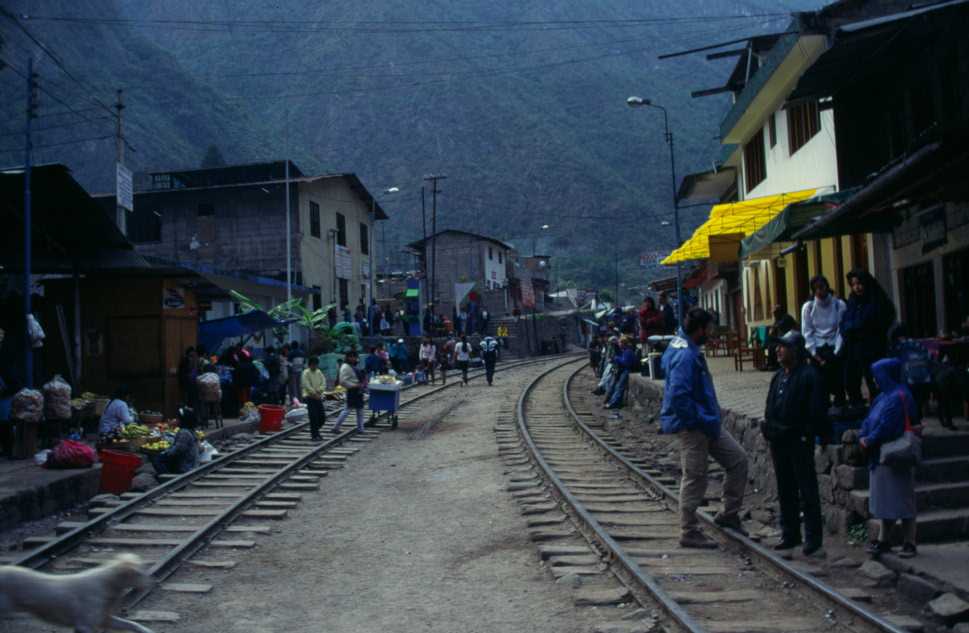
left=115, top=161, right=387, bottom=318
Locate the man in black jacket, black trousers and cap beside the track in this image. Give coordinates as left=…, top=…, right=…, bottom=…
left=763, top=330, right=830, bottom=556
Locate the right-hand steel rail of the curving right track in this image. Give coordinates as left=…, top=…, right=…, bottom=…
left=562, top=367, right=905, bottom=633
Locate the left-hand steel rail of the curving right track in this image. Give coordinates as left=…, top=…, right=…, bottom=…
left=517, top=361, right=706, bottom=633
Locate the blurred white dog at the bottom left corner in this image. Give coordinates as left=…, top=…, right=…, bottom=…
left=0, top=554, right=152, bottom=633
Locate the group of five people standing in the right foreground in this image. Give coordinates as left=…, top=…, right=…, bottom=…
left=656, top=270, right=964, bottom=557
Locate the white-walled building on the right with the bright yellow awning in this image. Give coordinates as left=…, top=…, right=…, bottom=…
left=664, top=14, right=874, bottom=337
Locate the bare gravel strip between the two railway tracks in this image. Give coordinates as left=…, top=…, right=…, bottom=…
left=132, top=366, right=596, bottom=633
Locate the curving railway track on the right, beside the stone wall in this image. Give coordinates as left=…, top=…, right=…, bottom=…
left=510, top=363, right=904, bottom=633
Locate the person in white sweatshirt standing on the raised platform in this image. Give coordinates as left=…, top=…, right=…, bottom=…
left=801, top=275, right=846, bottom=410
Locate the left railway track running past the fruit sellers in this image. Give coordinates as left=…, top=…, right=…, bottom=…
left=10, top=358, right=572, bottom=624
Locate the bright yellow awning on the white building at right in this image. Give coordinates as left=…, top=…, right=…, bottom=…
left=661, top=189, right=817, bottom=266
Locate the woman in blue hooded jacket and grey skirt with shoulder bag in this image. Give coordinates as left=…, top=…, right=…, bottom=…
left=859, top=358, right=919, bottom=558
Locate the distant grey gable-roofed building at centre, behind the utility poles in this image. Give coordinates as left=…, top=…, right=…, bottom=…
left=407, top=229, right=514, bottom=316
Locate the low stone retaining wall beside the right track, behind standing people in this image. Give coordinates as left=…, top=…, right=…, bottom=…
left=629, top=375, right=869, bottom=534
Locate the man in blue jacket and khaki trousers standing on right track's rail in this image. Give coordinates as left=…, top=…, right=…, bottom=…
left=660, top=308, right=747, bottom=548
